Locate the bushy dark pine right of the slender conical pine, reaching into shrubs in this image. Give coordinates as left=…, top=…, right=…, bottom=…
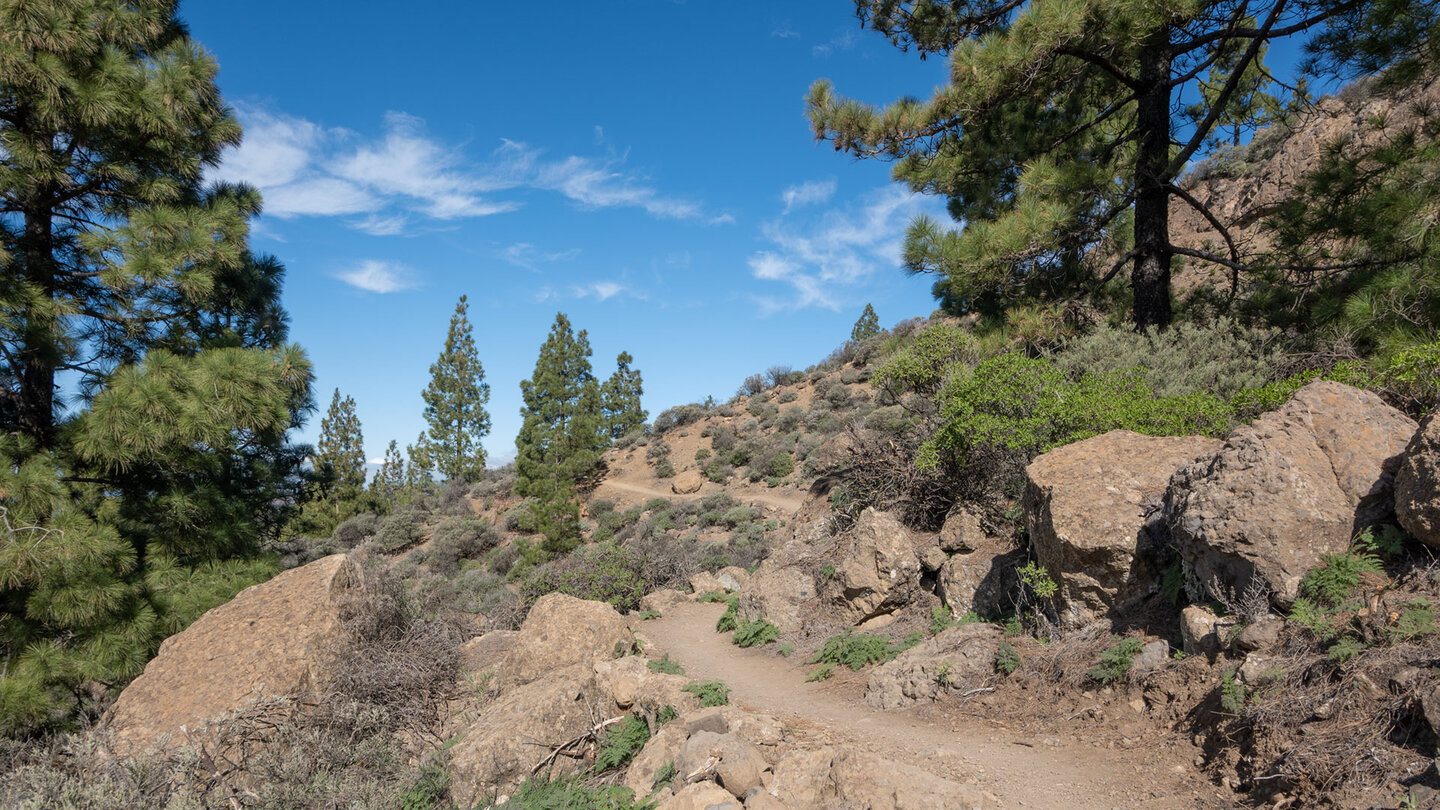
left=516, top=313, right=608, bottom=553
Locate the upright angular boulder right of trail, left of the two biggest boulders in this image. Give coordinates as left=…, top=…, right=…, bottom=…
left=835, top=507, right=920, bottom=624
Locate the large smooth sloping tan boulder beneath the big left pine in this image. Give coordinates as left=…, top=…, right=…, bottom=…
left=107, top=553, right=360, bottom=751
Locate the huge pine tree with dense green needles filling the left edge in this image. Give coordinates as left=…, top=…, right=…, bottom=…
left=0, top=0, right=311, bottom=731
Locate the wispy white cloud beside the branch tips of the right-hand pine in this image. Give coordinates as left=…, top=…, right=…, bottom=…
left=747, top=186, right=939, bottom=311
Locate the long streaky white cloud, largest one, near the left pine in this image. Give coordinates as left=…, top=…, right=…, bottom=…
left=210, top=105, right=714, bottom=236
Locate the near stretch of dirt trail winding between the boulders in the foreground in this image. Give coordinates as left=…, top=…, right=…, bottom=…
left=636, top=602, right=1233, bottom=810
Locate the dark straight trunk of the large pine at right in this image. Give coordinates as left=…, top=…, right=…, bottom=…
left=1130, top=27, right=1171, bottom=330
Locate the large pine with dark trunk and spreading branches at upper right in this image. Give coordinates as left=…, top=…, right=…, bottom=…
left=808, top=0, right=1434, bottom=329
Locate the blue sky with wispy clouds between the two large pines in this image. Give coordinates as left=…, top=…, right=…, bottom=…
left=181, top=0, right=945, bottom=463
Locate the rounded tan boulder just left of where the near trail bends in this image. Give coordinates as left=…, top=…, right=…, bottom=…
left=495, top=585, right=635, bottom=689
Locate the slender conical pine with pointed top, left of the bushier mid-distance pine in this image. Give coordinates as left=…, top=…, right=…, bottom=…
left=422, top=295, right=490, bottom=481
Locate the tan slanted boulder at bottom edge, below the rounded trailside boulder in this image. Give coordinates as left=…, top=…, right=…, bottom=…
left=449, top=664, right=599, bottom=807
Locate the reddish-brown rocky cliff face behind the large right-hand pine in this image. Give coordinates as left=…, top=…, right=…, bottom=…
left=1171, top=70, right=1440, bottom=290
